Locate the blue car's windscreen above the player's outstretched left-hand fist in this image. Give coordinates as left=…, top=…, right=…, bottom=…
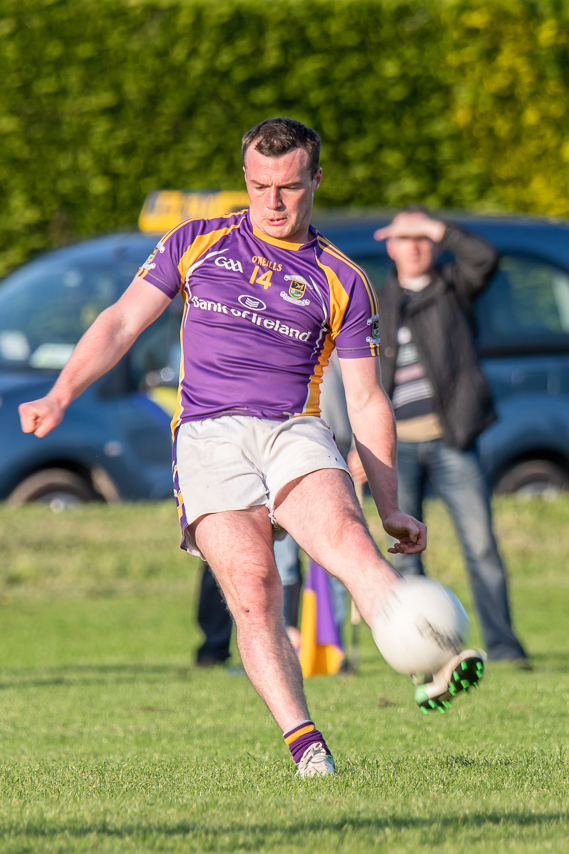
left=0, top=256, right=138, bottom=370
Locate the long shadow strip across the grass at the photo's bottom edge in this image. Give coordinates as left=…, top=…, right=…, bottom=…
left=0, top=812, right=569, bottom=852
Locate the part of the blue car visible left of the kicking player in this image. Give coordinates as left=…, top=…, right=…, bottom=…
left=0, top=234, right=175, bottom=509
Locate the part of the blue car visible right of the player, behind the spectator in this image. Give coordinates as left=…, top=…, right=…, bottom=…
left=325, top=211, right=569, bottom=497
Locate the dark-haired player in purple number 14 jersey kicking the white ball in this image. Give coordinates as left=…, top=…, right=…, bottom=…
left=20, top=118, right=480, bottom=777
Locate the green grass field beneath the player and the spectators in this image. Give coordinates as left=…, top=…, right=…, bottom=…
left=0, top=498, right=569, bottom=854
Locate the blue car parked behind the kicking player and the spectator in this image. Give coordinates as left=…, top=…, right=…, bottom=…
left=0, top=214, right=569, bottom=509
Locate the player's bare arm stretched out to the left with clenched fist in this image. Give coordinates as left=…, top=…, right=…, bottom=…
left=18, top=276, right=171, bottom=438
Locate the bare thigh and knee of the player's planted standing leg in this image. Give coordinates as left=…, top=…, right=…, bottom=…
left=192, top=506, right=282, bottom=620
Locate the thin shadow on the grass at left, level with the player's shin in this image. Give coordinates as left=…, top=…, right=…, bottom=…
left=0, top=664, right=200, bottom=691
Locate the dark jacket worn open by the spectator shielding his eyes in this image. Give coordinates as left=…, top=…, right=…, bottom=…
left=378, top=224, right=498, bottom=448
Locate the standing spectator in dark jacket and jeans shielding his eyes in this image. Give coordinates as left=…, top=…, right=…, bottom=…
left=353, top=208, right=527, bottom=666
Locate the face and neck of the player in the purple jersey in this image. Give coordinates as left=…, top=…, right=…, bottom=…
left=243, top=146, right=322, bottom=243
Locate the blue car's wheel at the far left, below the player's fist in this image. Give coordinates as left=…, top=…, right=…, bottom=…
left=8, top=469, right=100, bottom=512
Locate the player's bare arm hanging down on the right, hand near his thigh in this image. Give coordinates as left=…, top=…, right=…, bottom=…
left=340, top=358, right=427, bottom=554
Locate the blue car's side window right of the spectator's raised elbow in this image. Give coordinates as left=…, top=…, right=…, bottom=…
left=476, top=253, right=569, bottom=349
